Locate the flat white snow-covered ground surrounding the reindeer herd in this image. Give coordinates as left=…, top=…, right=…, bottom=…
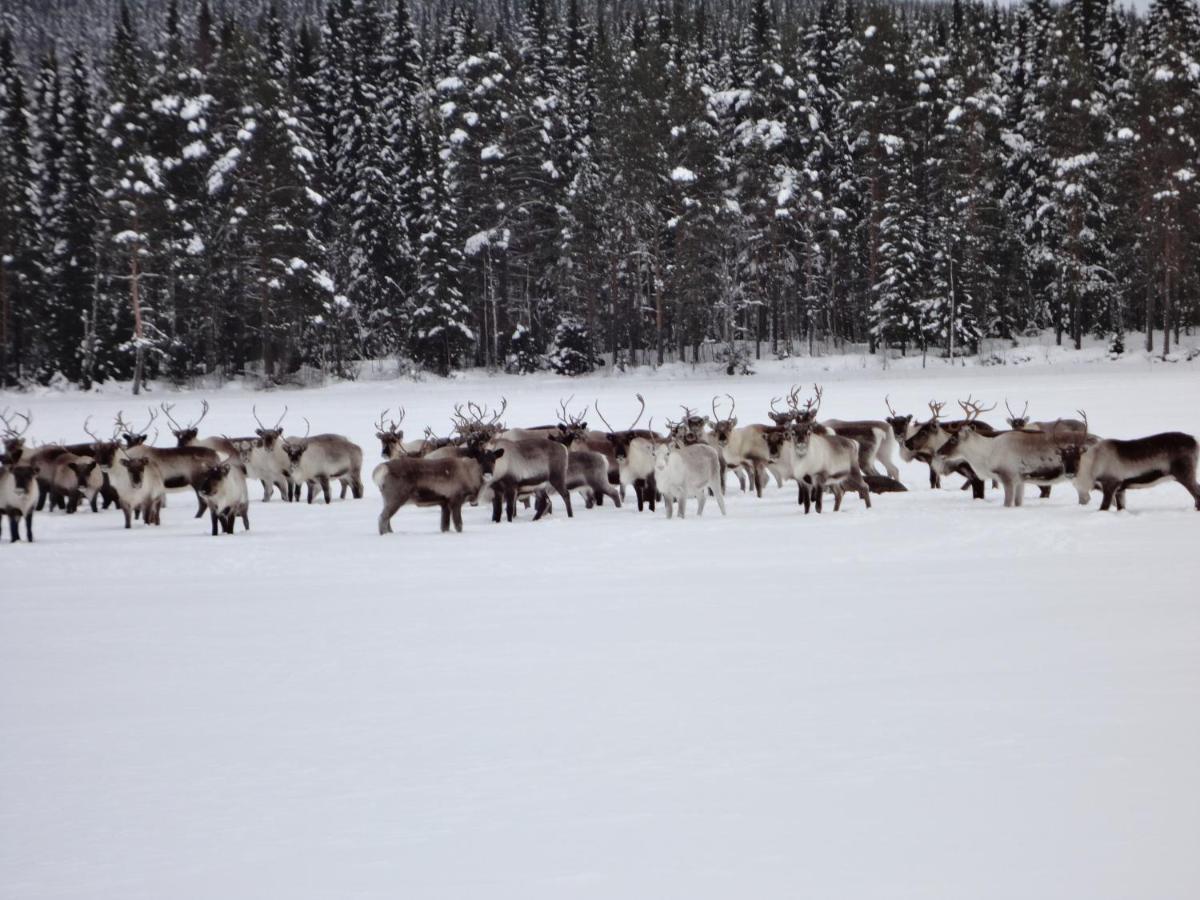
left=0, top=352, right=1200, bottom=900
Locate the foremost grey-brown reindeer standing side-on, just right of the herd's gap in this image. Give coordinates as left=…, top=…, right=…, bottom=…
left=371, top=446, right=505, bottom=534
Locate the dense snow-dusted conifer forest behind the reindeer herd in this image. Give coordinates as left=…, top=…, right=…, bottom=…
left=0, top=0, right=1200, bottom=386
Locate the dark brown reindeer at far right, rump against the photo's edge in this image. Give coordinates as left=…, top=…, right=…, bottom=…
left=1060, top=424, right=1200, bottom=511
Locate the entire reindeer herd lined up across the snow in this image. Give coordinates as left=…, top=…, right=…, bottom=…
left=0, top=385, right=1200, bottom=541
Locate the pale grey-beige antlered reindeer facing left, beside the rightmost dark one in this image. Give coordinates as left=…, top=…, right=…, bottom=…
left=936, top=397, right=1086, bottom=506
